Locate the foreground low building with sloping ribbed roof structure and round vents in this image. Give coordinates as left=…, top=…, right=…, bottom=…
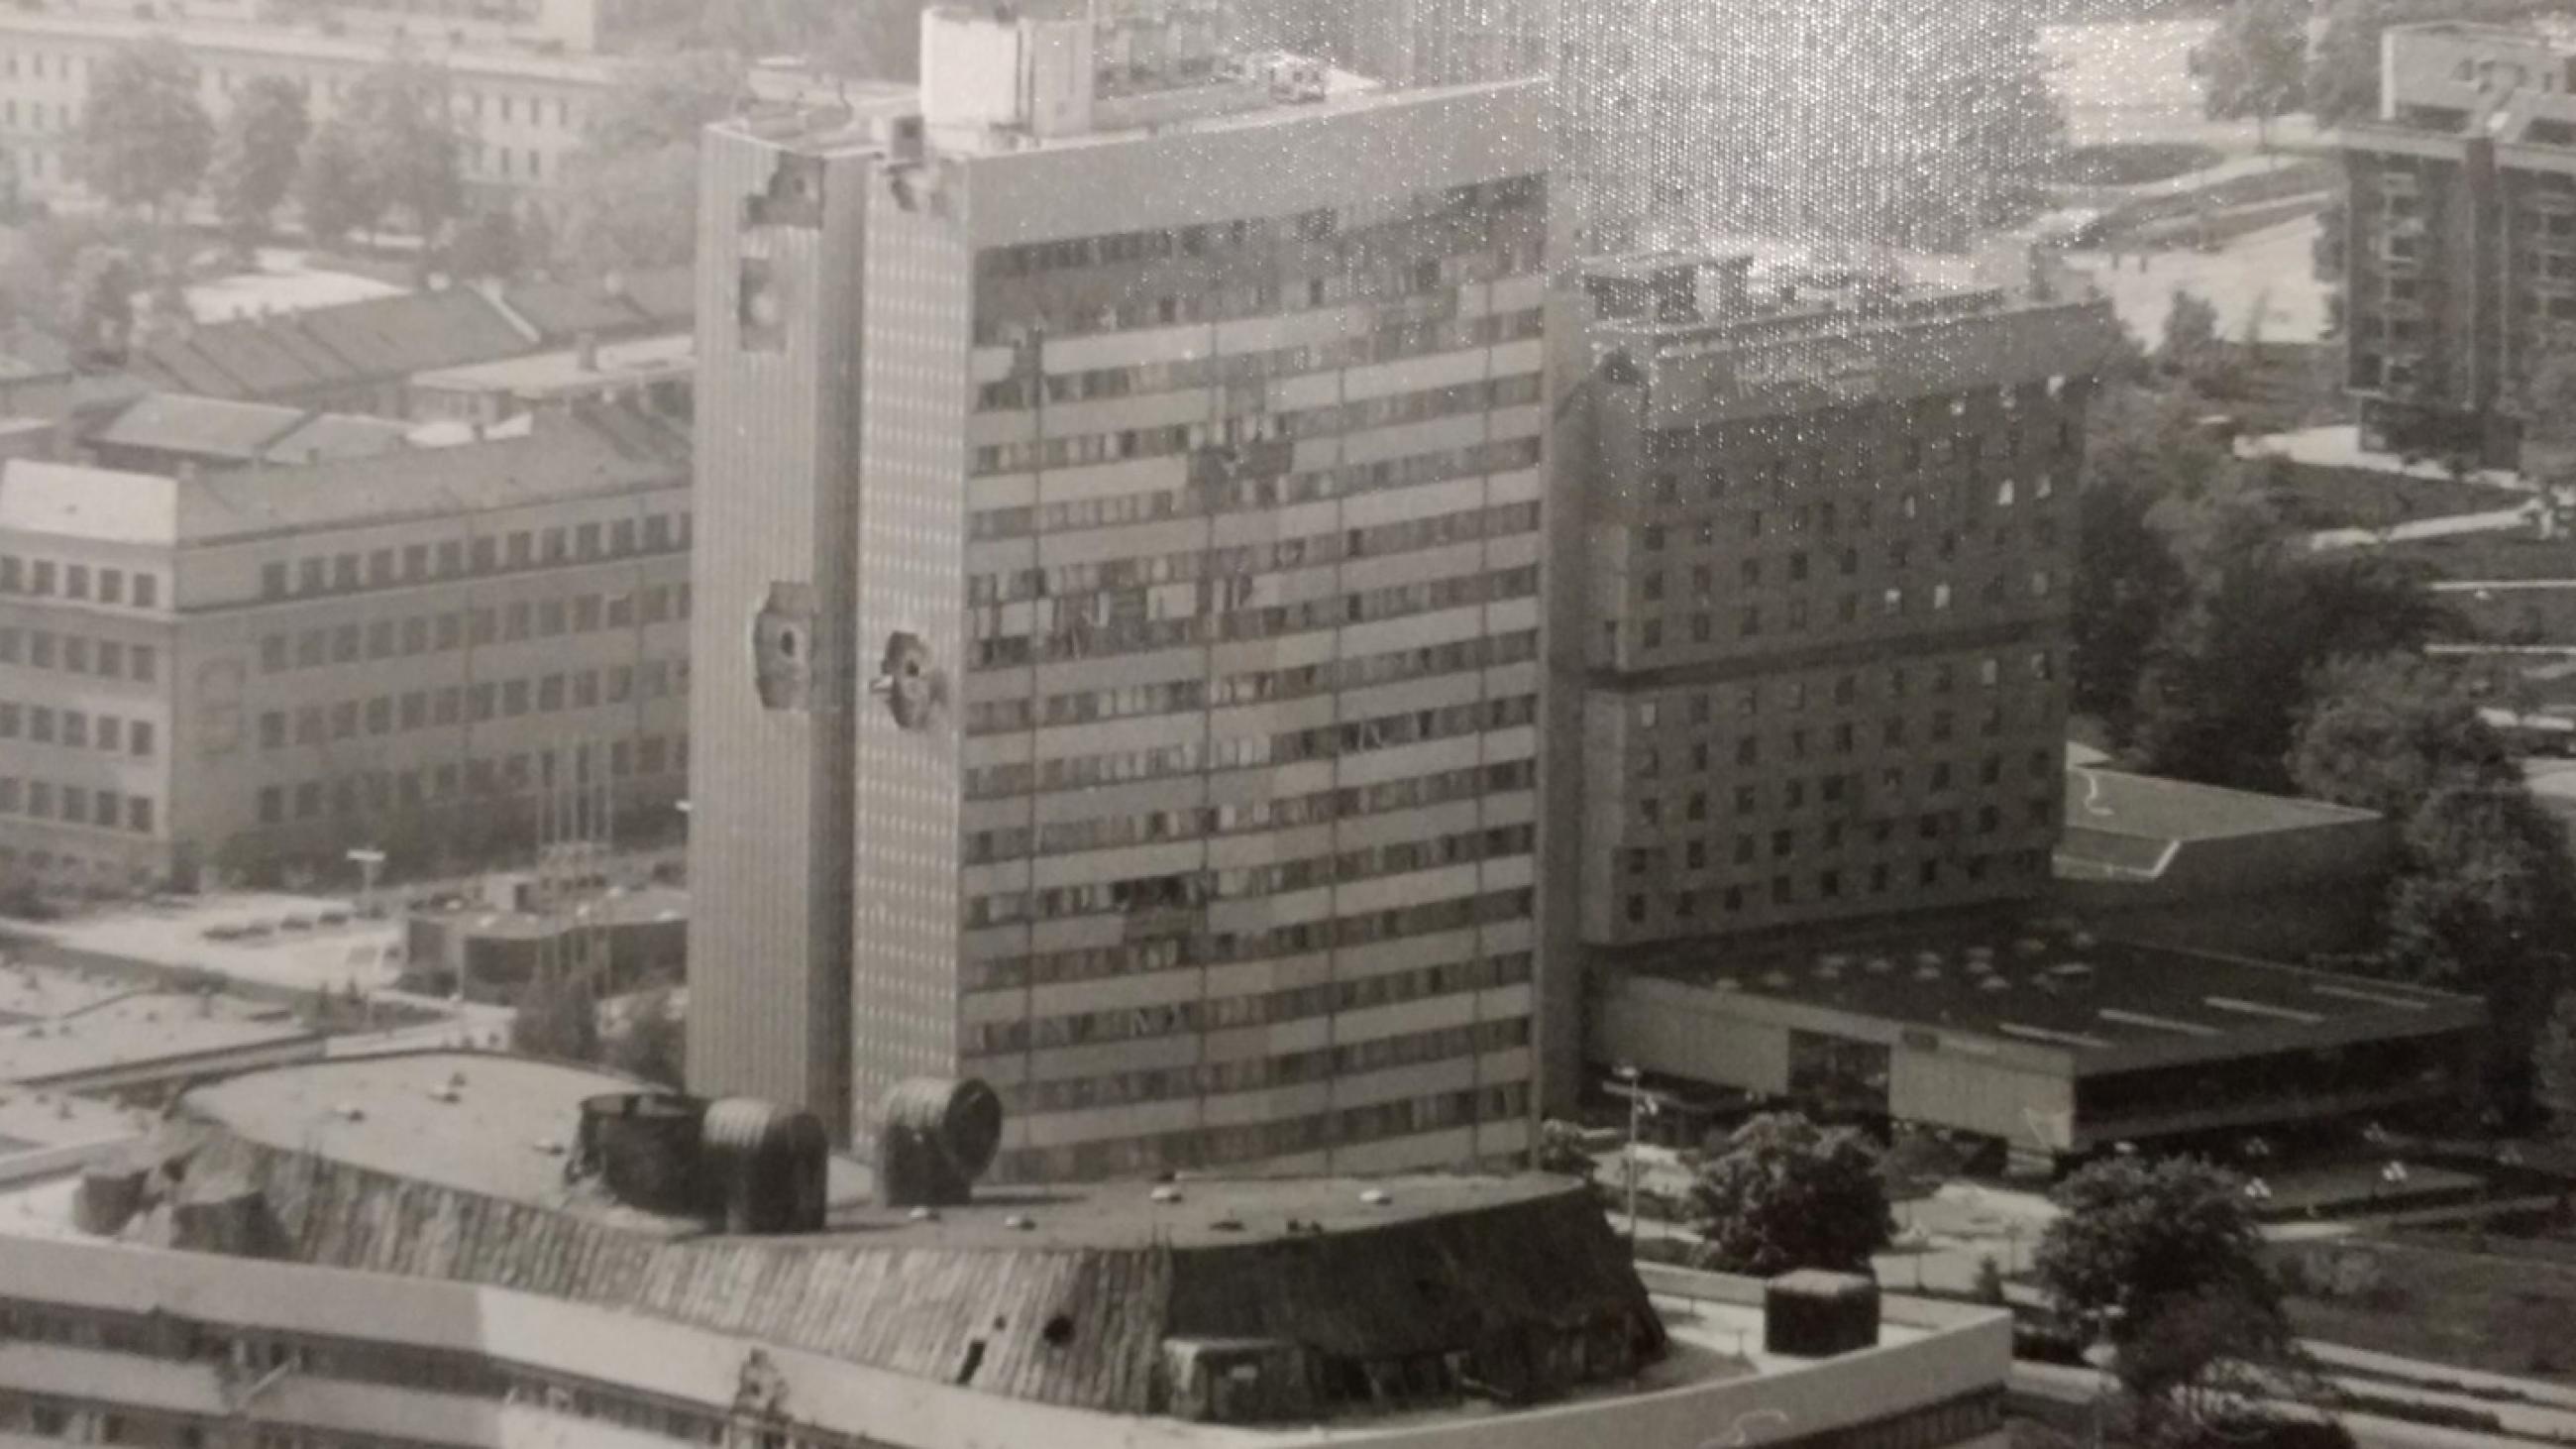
left=0, top=1052, right=2009, bottom=1449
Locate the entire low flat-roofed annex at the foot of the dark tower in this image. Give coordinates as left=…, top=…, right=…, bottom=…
left=1592, top=921, right=2486, bottom=1168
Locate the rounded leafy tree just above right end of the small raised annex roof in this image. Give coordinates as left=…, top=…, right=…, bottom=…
left=2290, top=655, right=2522, bottom=823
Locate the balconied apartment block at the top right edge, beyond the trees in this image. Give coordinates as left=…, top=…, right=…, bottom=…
left=2334, top=23, right=2576, bottom=467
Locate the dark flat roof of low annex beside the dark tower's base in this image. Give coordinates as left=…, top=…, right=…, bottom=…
left=1631, top=923, right=2483, bottom=1070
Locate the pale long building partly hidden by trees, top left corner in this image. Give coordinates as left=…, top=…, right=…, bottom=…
left=0, top=0, right=618, bottom=201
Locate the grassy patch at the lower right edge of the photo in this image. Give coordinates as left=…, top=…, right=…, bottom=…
left=2290, top=1238, right=2576, bottom=1385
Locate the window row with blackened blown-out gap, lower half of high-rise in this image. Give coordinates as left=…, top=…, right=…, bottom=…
left=963, top=889, right=1538, bottom=990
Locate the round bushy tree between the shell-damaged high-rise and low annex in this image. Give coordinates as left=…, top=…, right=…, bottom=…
left=1690, top=1111, right=1893, bottom=1277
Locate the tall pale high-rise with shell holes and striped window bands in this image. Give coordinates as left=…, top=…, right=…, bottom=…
left=688, top=5, right=1549, bottom=1178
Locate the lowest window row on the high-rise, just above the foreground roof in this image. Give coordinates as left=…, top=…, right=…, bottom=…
left=995, top=1083, right=1530, bottom=1180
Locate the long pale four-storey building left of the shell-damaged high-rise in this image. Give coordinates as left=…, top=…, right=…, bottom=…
left=0, top=399, right=691, bottom=887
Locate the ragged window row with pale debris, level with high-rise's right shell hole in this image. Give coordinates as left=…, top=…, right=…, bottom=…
left=969, top=565, right=1538, bottom=668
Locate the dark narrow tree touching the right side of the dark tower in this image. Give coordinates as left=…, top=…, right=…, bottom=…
left=2069, top=477, right=2190, bottom=745
